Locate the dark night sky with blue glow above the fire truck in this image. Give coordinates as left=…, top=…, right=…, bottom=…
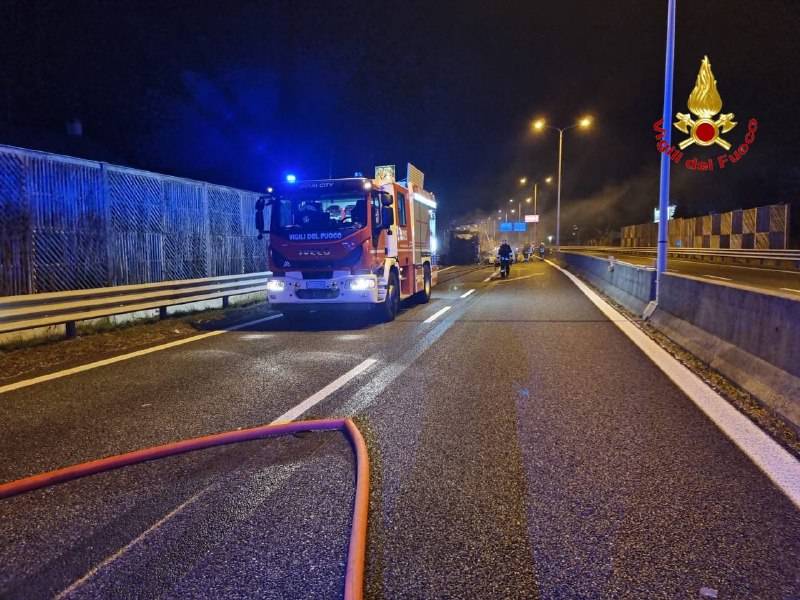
left=0, top=0, right=800, bottom=237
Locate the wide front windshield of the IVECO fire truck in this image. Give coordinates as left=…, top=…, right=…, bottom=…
left=272, top=193, right=368, bottom=240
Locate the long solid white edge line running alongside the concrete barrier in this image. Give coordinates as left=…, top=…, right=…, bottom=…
left=547, top=260, right=800, bottom=509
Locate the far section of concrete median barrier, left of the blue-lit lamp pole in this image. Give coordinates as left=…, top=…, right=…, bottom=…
left=557, top=252, right=656, bottom=315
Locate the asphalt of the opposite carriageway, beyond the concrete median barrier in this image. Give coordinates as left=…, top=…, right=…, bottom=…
left=564, top=250, right=800, bottom=300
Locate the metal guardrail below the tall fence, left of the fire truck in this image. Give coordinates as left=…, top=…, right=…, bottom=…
left=0, top=272, right=267, bottom=337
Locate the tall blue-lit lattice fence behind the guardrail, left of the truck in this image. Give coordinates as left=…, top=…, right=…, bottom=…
left=0, top=145, right=266, bottom=296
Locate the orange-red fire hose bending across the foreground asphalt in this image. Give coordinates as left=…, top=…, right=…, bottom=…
left=0, top=419, right=369, bottom=600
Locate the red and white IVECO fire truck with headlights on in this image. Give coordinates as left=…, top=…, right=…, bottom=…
left=256, top=166, right=437, bottom=321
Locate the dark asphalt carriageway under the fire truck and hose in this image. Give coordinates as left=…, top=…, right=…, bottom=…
left=0, top=262, right=800, bottom=600
